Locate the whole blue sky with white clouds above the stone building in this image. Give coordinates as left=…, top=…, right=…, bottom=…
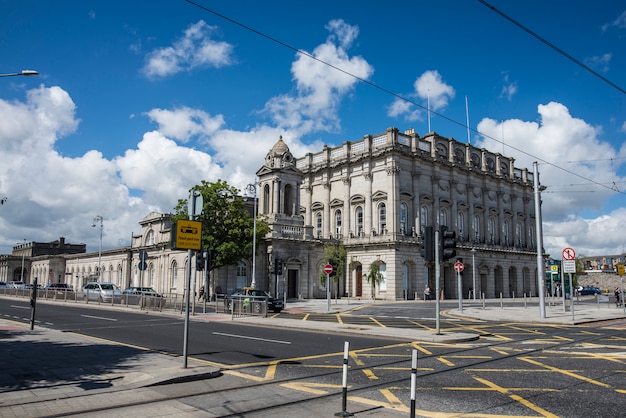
left=0, top=0, right=626, bottom=258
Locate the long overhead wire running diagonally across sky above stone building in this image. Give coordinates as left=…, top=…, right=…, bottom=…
left=185, top=0, right=626, bottom=193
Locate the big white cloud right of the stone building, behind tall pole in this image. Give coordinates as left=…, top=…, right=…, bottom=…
left=476, top=102, right=626, bottom=258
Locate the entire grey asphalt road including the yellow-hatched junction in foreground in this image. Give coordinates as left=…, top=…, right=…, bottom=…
left=0, top=300, right=626, bottom=417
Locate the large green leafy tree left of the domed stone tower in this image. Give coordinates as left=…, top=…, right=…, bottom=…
left=173, top=180, right=270, bottom=270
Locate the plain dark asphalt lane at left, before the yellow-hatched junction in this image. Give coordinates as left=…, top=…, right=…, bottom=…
left=0, top=299, right=395, bottom=368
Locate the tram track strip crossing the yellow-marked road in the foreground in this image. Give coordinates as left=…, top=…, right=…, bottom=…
left=20, top=324, right=623, bottom=417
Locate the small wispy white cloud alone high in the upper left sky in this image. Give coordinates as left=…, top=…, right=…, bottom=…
left=142, top=20, right=233, bottom=78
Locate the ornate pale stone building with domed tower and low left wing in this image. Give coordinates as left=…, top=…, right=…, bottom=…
left=1, top=128, right=537, bottom=300
